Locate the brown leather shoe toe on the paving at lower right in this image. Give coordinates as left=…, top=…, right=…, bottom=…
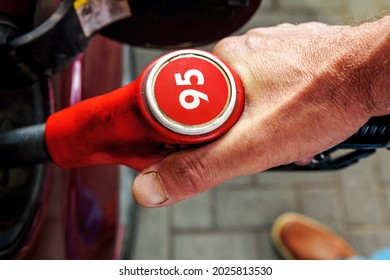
left=272, top=213, right=357, bottom=260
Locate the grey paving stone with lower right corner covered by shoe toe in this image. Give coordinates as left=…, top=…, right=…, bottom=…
left=216, top=189, right=296, bottom=227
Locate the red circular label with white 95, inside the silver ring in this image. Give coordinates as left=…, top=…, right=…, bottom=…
left=154, top=56, right=230, bottom=125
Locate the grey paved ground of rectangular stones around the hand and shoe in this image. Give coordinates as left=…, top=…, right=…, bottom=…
left=130, top=0, right=390, bottom=259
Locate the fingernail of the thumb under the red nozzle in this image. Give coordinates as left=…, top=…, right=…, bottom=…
left=134, top=171, right=168, bottom=207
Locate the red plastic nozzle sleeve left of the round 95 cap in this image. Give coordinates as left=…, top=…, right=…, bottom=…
left=45, top=77, right=168, bottom=170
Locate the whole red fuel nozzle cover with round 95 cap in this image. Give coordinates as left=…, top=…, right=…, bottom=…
left=45, top=50, right=244, bottom=170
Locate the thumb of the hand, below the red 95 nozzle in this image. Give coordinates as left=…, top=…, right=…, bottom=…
left=133, top=143, right=234, bottom=207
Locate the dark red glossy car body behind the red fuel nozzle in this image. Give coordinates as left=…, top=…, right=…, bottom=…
left=26, top=36, right=125, bottom=259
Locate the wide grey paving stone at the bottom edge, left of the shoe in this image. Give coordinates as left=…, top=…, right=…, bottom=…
left=174, top=232, right=257, bottom=260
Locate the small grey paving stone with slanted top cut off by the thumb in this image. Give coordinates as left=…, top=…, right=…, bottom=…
left=173, top=191, right=212, bottom=229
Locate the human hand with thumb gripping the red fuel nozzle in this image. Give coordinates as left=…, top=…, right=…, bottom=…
left=133, top=19, right=390, bottom=207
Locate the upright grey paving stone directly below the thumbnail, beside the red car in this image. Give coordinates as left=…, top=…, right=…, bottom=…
left=134, top=207, right=172, bottom=260
